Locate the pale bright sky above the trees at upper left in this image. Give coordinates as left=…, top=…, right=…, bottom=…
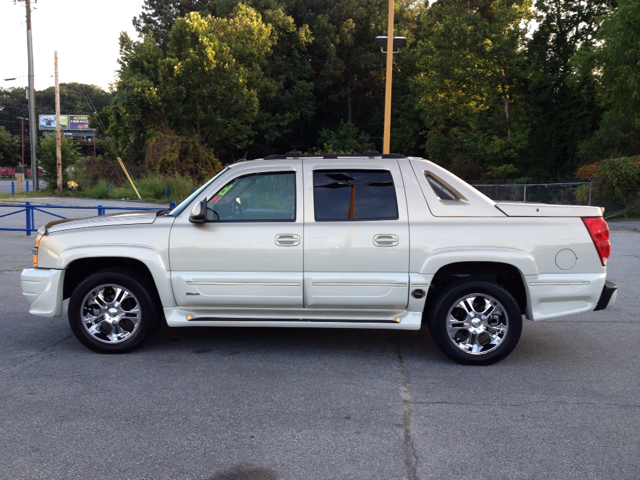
left=0, top=0, right=143, bottom=90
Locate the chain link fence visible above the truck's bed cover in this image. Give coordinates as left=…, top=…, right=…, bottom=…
left=472, top=181, right=596, bottom=205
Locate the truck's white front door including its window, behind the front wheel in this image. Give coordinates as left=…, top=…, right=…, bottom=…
left=170, top=160, right=304, bottom=309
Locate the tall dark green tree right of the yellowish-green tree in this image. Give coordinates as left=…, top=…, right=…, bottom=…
left=521, top=0, right=613, bottom=178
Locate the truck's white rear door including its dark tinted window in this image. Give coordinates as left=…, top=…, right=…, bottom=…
left=303, top=159, right=409, bottom=309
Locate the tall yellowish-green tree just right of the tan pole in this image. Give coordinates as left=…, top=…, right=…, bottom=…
left=410, top=0, right=531, bottom=177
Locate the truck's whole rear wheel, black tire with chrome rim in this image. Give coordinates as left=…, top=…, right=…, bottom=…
left=427, top=279, right=522, bottom=365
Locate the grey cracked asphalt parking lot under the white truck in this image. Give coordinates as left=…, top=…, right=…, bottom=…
left=0, top=201, right=640, bottom=480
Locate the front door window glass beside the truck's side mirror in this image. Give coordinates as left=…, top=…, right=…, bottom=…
left=207, top=172, right=296, bottom=222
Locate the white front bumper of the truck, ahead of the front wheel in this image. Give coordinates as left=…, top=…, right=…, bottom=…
left=20, top=268, right=64, bottom=317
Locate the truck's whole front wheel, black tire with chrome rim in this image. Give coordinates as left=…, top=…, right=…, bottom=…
left=68, top=268, right=161, bottom=353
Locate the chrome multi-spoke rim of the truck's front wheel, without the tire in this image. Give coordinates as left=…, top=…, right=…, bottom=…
left=80, top=284, right=141, bottom=344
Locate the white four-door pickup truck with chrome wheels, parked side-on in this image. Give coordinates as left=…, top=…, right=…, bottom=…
left=21, top=152, right=617, bottom=365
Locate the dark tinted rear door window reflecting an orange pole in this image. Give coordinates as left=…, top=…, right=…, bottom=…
left=313, top=170, right=398, bottom=222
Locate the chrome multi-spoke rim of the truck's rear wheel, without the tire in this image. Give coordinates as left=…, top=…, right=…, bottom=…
left=447, top=293, right=509, bottom=355
